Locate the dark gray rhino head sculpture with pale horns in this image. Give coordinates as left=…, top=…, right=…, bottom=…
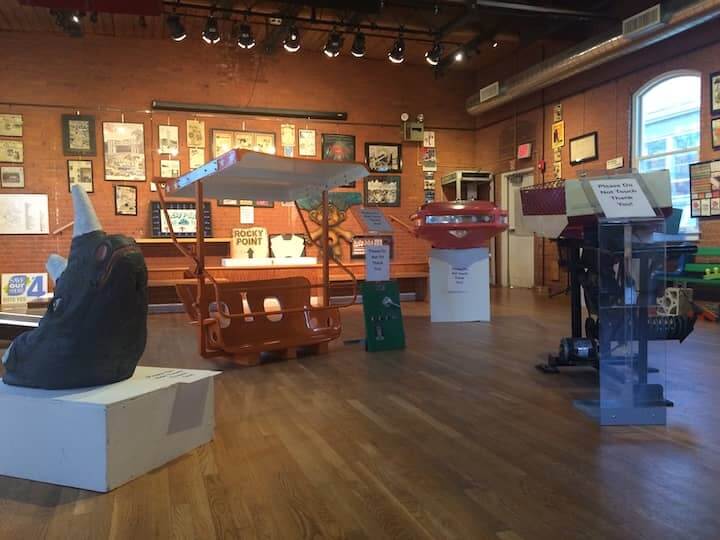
left=2, top=185, right=147, bottom=389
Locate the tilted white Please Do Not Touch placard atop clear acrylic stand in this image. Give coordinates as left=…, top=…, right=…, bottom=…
left=590, top=177, right=655, bottom=219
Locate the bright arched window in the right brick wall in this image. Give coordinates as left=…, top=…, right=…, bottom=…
left=633, top=71, right=701, bottom=232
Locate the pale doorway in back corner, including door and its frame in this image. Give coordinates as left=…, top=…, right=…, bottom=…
left=500, top=169, right=535, bottom=288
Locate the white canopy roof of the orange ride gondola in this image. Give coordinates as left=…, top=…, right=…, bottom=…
left=165, top=149, right=370, bottom=201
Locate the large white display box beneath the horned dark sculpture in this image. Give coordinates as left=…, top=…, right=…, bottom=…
left=0, top=366, right=219, bottom=492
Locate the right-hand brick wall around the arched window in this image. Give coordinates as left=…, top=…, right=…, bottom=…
left=476, top=21, right=720, bottom=287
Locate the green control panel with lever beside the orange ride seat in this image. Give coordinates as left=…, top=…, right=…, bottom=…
left=361, top=281, right=405, bottom=352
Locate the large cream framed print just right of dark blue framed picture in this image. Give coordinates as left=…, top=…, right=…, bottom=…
left=103, top=122, right=146, bottom=182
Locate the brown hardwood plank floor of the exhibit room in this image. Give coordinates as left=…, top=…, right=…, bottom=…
left=0, top=290, right=720, bottom=540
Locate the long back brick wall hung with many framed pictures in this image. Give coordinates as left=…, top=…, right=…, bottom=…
left=0, top=33, right=475, bottom=278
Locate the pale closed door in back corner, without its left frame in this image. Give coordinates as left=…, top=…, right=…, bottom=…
left=507, top=173, right=535, bottom=288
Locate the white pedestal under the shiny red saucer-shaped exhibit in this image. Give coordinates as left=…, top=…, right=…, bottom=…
left=430, top=248, right=490, bottom=322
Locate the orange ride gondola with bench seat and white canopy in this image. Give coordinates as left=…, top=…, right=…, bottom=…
left=158, top=150, right=368, bottom=365
